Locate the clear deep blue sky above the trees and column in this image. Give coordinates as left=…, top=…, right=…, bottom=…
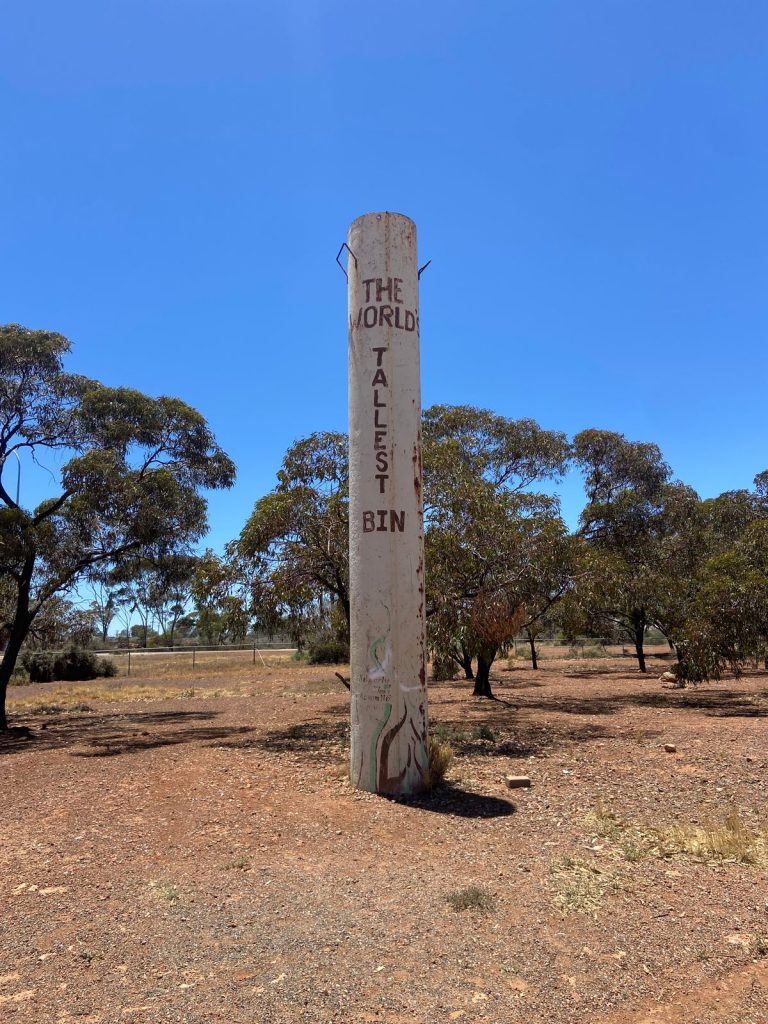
left=0, top=0, right=768, bottom=547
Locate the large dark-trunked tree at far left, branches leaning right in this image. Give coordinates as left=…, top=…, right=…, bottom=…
left=0, top=324, right=234, bottom=729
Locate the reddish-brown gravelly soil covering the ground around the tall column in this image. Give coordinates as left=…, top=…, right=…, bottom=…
left=0, top=659, right=768, bottom=1024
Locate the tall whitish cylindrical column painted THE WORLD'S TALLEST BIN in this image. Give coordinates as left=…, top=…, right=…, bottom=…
left=347, top=213, right=427, bottom=795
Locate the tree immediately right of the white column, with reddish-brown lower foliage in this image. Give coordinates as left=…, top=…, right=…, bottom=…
left=424, top=406, right=569, bottom=697
